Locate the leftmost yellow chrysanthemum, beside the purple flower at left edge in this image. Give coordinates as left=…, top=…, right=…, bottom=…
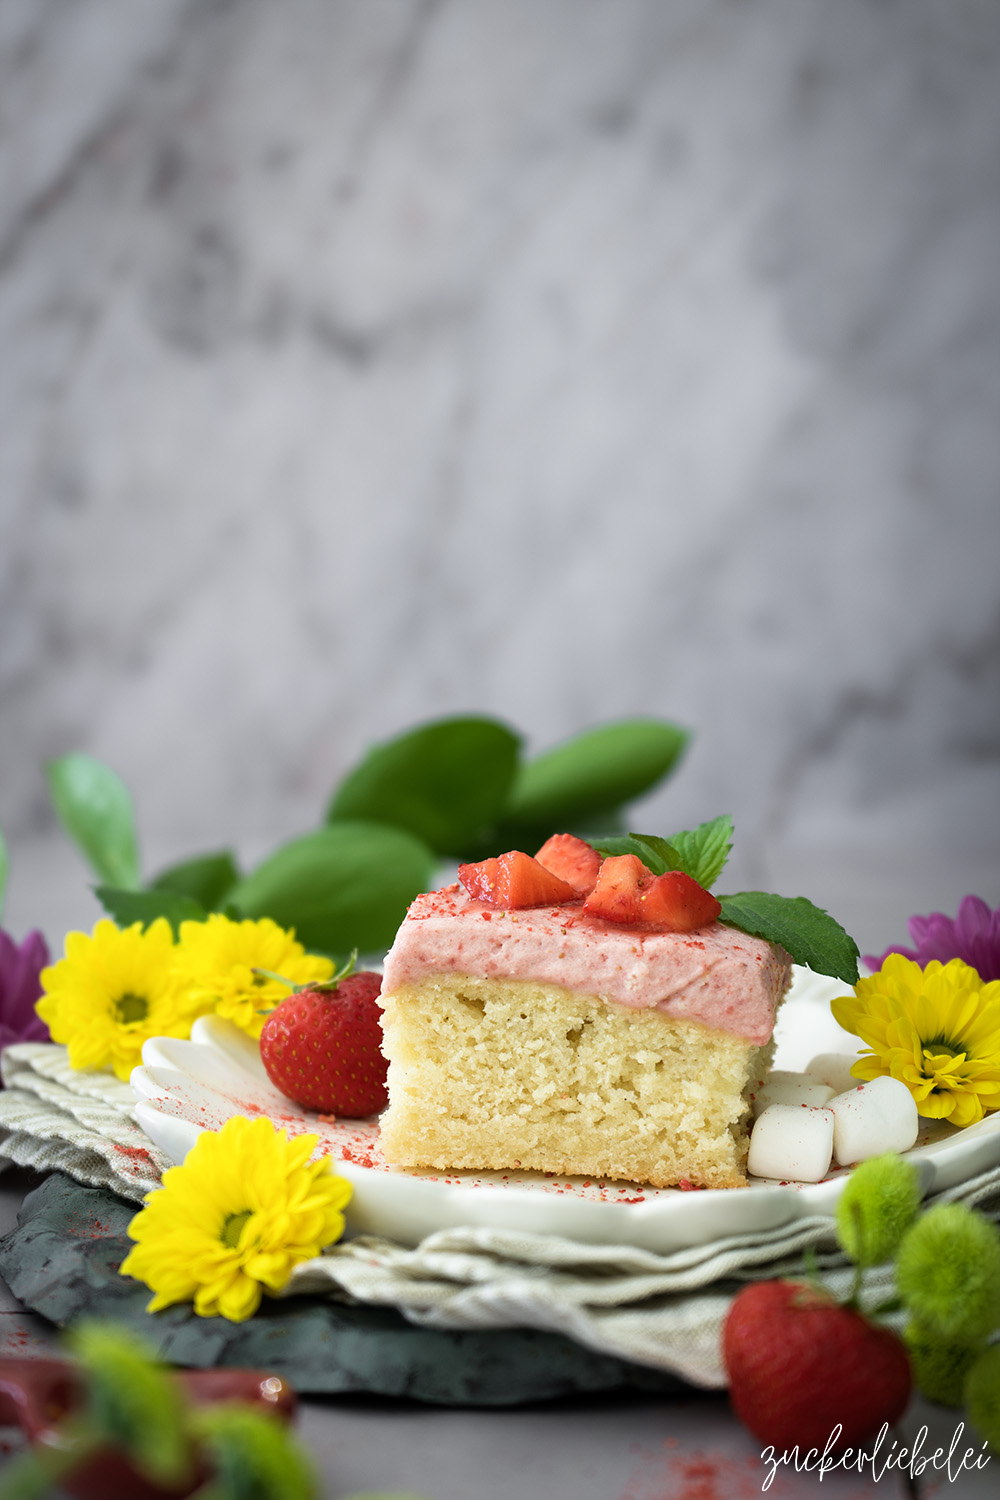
left=36, top=917, right=192, bottom=1080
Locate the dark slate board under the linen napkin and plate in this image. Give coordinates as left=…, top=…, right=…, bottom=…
left=0, top=1173, right=690, bottom=1407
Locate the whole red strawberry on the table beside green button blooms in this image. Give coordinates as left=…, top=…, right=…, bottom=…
left=723, top=1281, right=910, bottom=1452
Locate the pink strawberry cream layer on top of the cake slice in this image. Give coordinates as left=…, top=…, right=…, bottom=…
left=382, top=885, right=792, bottom=1046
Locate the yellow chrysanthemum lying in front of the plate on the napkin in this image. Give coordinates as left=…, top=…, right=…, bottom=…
left=120, top=1116, right=351, bottom=1323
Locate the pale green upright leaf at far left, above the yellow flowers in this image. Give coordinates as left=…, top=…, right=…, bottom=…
left=45, top=752, right=139, bottom=890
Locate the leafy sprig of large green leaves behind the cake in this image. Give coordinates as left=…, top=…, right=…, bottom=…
left=48, top=714, right=690, bottom=957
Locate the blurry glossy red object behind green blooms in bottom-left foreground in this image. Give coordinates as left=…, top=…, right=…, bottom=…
left=0, top=1359, right=295, bottom=1500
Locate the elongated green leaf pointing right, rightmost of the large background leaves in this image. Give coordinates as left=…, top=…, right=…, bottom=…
left=504, top=719, right=690, bottom=833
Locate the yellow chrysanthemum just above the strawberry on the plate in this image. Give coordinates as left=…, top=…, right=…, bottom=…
left=175, top=912, right=333, bottom=1037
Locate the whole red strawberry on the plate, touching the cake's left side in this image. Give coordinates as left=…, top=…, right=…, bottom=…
left=261, top=969, right=388, bottom=1119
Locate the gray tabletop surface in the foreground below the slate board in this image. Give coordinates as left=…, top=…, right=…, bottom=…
left=0, top=1169, right=1000, bottom=1500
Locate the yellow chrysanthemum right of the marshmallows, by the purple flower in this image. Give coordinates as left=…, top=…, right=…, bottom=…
left=831, top=953, right=1000, bottom=1125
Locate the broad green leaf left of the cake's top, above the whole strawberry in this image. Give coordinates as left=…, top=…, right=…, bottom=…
left=229, top=822, right=436, bottom=956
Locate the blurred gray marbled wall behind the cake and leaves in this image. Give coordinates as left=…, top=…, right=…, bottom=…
left=0, top=0, right=1000, bottom=945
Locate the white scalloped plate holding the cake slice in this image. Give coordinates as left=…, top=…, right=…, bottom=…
left=132, top=969, right=1000, bottom=1253
